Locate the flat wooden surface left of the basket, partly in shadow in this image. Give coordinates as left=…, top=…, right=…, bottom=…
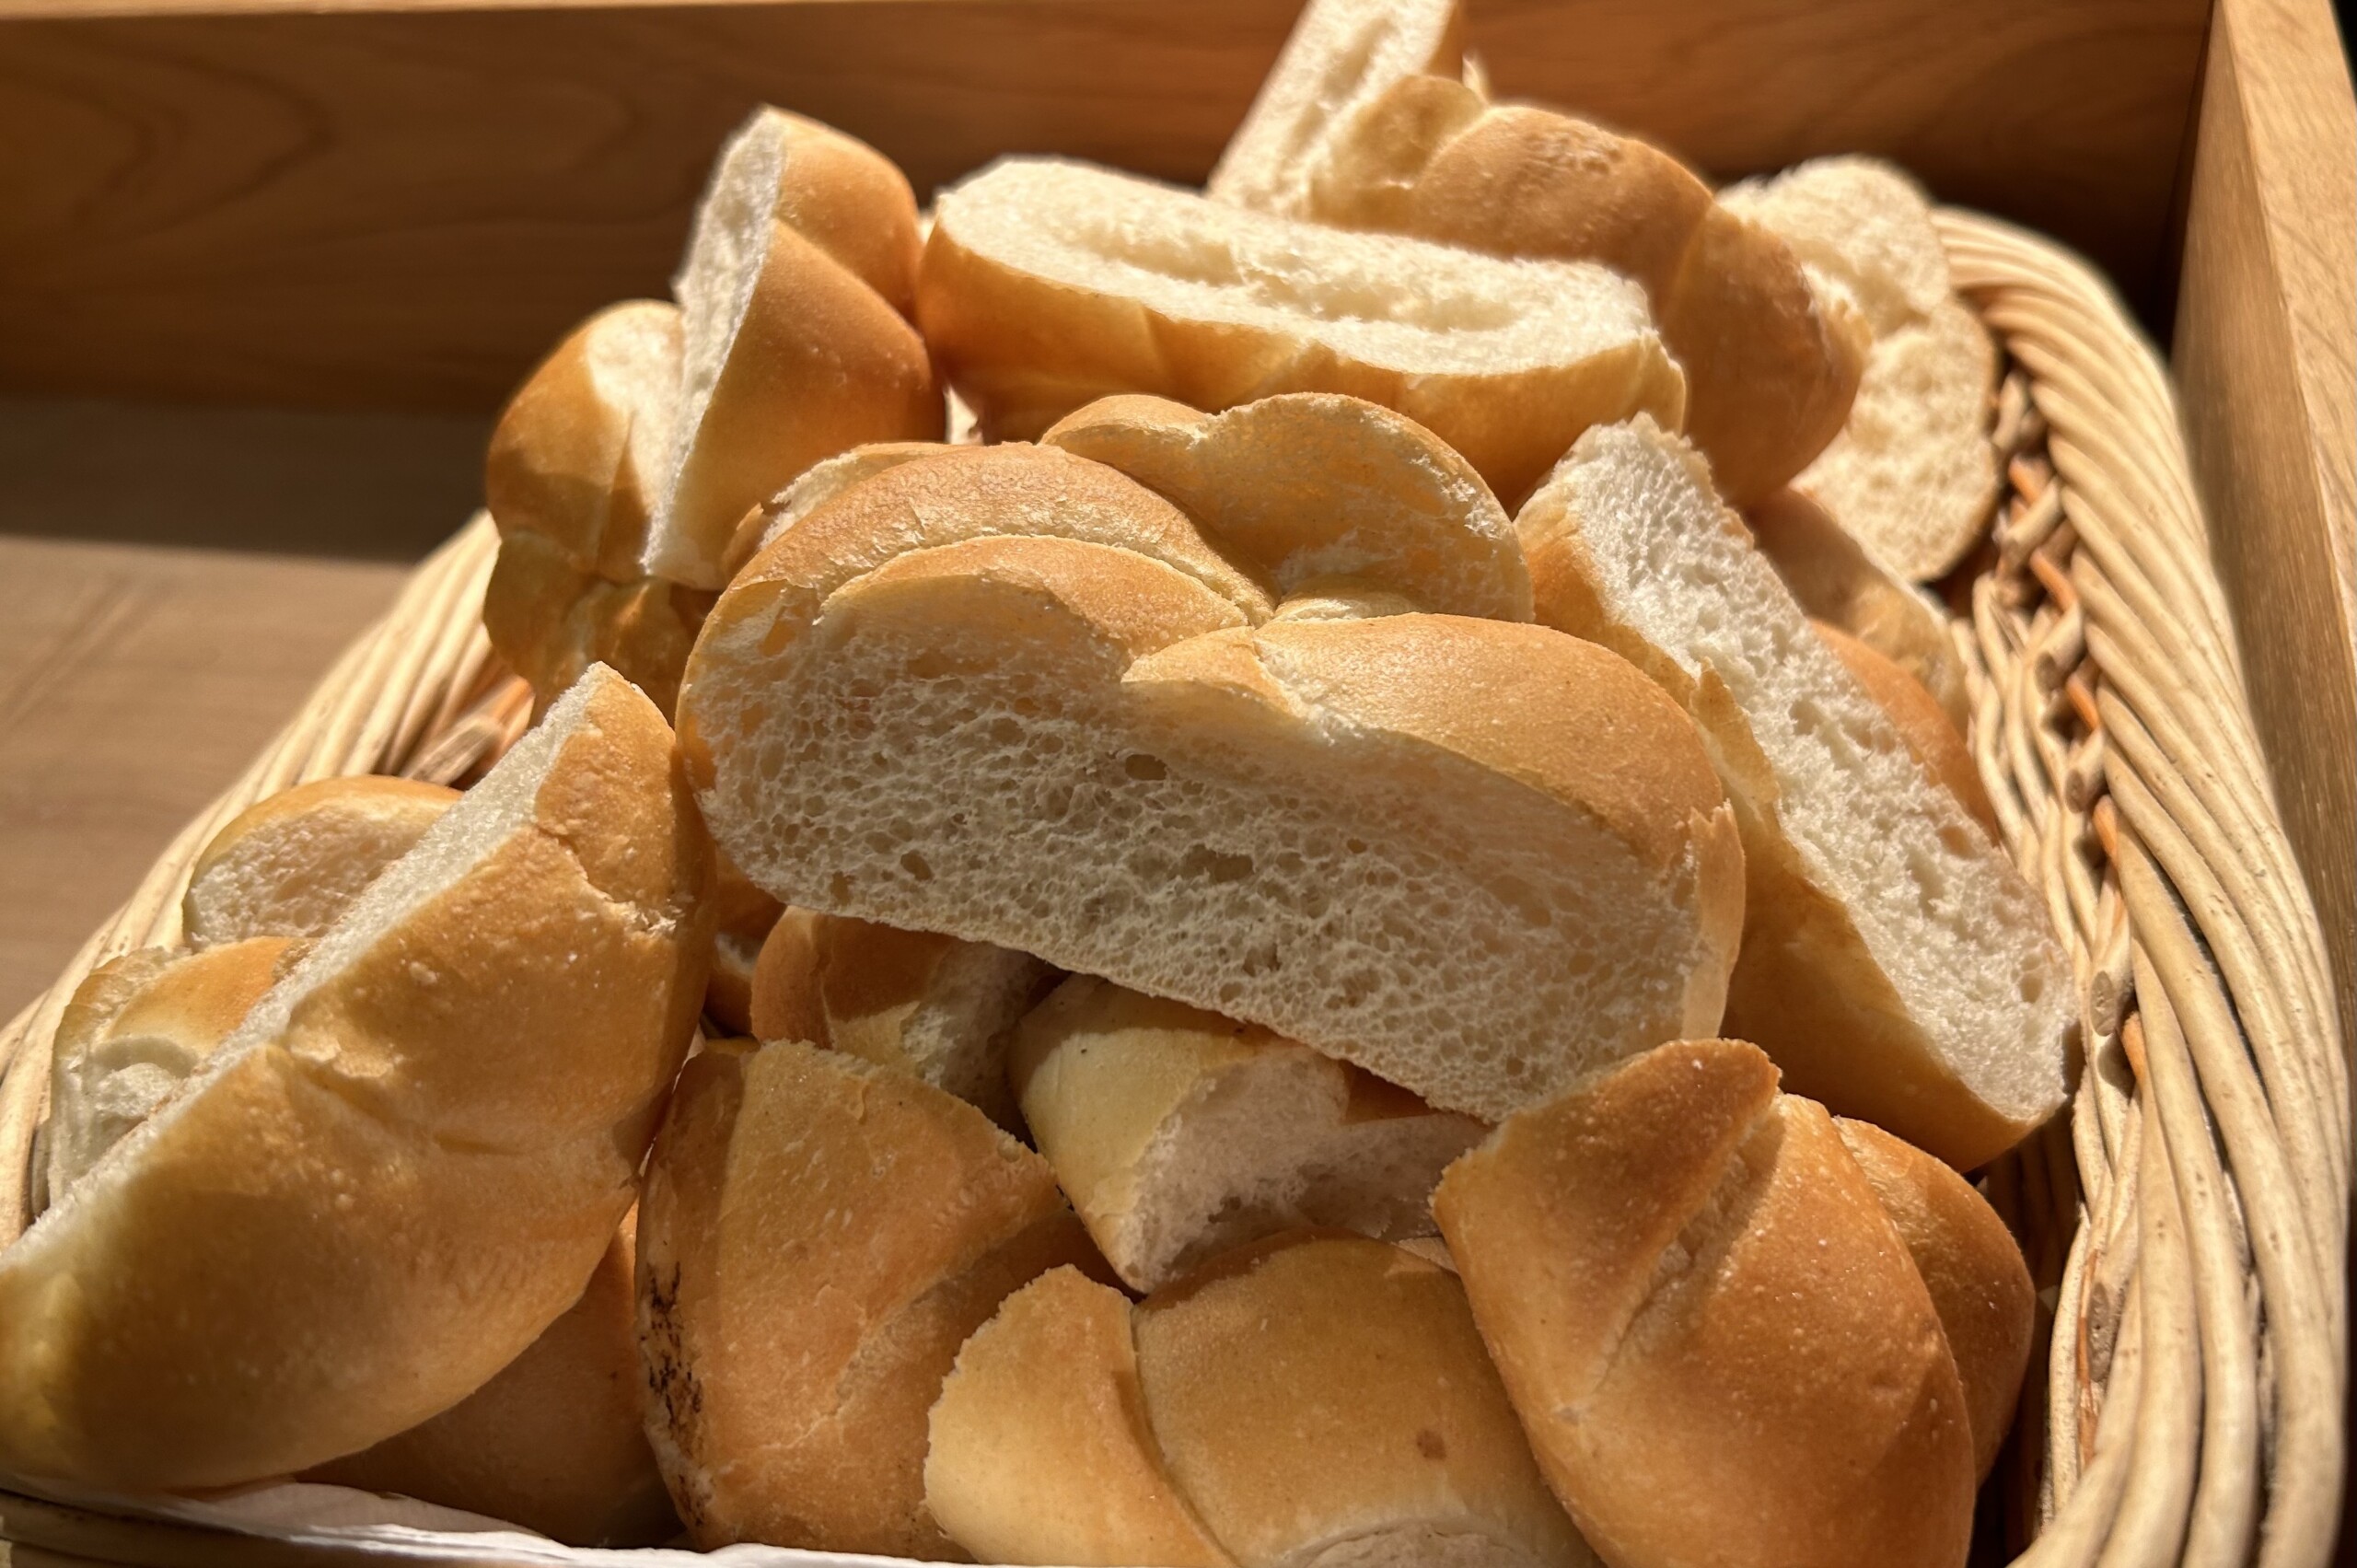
left=0, top=403, right=485, bottom=1018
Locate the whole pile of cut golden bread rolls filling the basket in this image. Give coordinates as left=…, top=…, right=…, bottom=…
left=0, top=0, right=2072, bottom=1568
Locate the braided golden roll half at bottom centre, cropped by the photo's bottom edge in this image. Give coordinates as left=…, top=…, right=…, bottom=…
left=926, top=1231, right=1596, bottom=1568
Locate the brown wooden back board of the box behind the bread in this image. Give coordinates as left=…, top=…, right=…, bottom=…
left=0, top=0, right=2206, bottom=411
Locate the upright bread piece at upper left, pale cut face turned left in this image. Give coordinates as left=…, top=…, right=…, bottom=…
left=645, top=109, right=943, bottom=589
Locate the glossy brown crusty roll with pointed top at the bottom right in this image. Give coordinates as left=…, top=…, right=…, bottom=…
left=1433, top=1040, right=1975, bottom=1568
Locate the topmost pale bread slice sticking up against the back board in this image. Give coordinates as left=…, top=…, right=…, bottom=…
left=1202, top=0, right=1464, bottom=217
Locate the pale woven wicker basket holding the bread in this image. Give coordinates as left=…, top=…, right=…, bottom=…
left=0, top=212, right=2350, bottom=1568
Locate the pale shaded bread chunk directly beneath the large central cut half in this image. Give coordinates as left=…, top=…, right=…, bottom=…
left=1009, top=974, right=1487, bottom=1290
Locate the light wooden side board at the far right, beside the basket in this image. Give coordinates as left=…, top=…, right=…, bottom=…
left=2173, top=0, right=2357, bottom=1042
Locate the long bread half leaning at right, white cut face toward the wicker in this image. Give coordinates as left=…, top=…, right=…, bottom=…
left=1518, top=420, right=2074, bottom=1169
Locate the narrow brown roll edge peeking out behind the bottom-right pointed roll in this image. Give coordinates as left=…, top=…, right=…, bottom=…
left=1834, top=1118, right=2038, bottom=1481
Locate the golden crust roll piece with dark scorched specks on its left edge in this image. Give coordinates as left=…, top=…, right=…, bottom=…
left=639, top=1040, right=1103, bottom=1559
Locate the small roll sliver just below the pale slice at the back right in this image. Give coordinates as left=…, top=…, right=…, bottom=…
left=1744, top=491, right=1973, bottom=733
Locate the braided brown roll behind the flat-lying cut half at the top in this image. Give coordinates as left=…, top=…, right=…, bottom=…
left=1304, top=75, right=1867, bottom=500
